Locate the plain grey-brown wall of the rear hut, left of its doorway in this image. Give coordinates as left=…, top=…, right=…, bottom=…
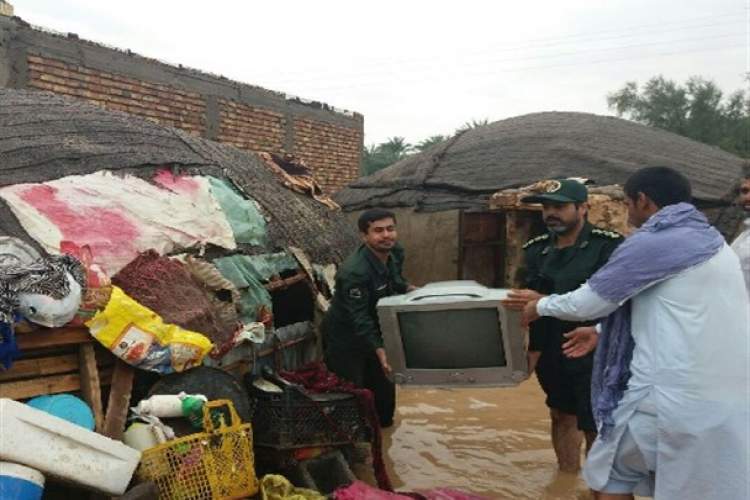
left=347, top=208, right=459, bottom=285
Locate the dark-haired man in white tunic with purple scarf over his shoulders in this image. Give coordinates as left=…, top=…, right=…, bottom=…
left=524, top=167, right=750, bottom=500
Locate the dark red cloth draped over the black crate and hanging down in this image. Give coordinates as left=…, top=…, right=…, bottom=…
left=280, top=362, right=393, bottom=490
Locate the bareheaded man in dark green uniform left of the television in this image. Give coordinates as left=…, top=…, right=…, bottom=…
left=323, top=209, right=414, bottom=427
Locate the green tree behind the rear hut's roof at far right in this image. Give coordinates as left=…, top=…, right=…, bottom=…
left=607, top=76, right=750, bottom=158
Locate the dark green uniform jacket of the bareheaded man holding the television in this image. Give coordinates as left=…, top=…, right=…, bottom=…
left=323, top=244, right=408, bottom=355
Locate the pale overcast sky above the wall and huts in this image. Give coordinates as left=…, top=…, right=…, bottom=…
left=9, top=0, right=750, bottom=144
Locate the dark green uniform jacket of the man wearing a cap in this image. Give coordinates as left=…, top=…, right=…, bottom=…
left=524, top=222, right=624, bottom=369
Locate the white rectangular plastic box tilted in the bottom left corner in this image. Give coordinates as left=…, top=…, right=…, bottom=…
left=0, top=398, right=141, bottom=495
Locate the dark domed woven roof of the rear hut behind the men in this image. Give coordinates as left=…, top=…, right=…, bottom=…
left=334, top=112, right=743, bottom=211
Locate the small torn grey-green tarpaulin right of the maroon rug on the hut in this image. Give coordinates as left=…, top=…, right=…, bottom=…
left=214, top=255, right=272, bottom=324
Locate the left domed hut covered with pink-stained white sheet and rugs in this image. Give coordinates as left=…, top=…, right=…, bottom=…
left=0, top=89, right=358, bottom=437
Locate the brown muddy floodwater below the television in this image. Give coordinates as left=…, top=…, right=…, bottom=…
left=384, top=378, right=590, bottom=500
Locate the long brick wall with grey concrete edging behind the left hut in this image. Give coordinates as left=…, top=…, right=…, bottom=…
left=0, top=16, right=364, bottom=193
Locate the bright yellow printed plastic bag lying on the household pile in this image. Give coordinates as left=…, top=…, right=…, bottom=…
left=86, top=286, right=213, bottom=374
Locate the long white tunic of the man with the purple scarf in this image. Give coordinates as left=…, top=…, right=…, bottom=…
left=537, top=245, right=750, bottom=500
